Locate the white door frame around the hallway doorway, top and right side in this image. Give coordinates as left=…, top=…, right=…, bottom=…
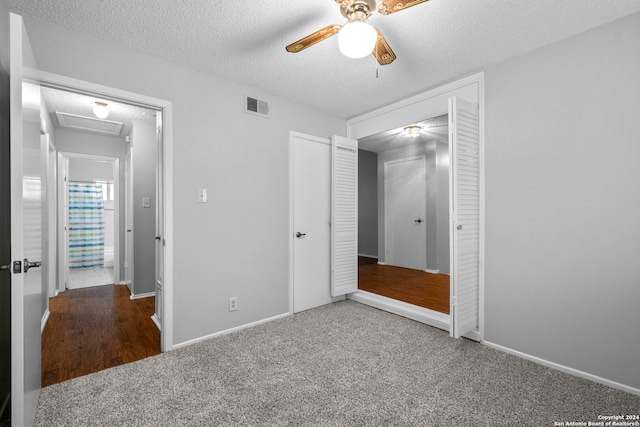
left=28, top=71, right=174, bottom=352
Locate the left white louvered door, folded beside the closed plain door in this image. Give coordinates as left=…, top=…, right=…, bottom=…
left=331, top=135, right=358, bottom=297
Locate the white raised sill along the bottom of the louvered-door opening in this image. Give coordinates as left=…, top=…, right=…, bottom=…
left=349, top=291, right=449, bottom=331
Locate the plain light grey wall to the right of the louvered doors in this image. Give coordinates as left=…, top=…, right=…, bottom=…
left=485, top=14, right=640, bottom=388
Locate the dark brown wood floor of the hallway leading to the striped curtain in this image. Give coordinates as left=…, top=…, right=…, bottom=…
left=42, top=285, right=160, bottom=387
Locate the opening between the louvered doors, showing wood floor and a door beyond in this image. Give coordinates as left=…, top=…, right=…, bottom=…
left=358, top=114, right=450, bottom=315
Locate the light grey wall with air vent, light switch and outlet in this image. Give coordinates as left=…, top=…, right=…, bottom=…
left=25, top=18, right=346, bottom=344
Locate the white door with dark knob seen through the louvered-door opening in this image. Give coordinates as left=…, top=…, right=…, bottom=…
left=384, top=157, right=427, bottom=270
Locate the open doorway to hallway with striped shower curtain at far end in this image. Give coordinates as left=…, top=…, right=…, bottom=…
left=35, top=76, right=170, bottom=385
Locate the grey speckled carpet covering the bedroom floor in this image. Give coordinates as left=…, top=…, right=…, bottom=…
left=36, top=301, right=640, bottom=426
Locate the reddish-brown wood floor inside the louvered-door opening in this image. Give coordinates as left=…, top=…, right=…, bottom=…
left=358, top=257, right=450, bottom=314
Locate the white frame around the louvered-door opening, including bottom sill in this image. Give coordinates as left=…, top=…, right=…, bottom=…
left=347, top=72, right=485, bottom=342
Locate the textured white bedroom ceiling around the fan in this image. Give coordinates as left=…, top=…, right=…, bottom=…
left=9, top=0, right=640, bottom=118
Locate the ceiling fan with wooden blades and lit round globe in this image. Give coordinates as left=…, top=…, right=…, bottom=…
left=286, top=0, right=428, bottom=65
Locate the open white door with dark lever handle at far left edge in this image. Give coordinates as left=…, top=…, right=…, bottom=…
left=10, top=14, right=46, bottom=426
